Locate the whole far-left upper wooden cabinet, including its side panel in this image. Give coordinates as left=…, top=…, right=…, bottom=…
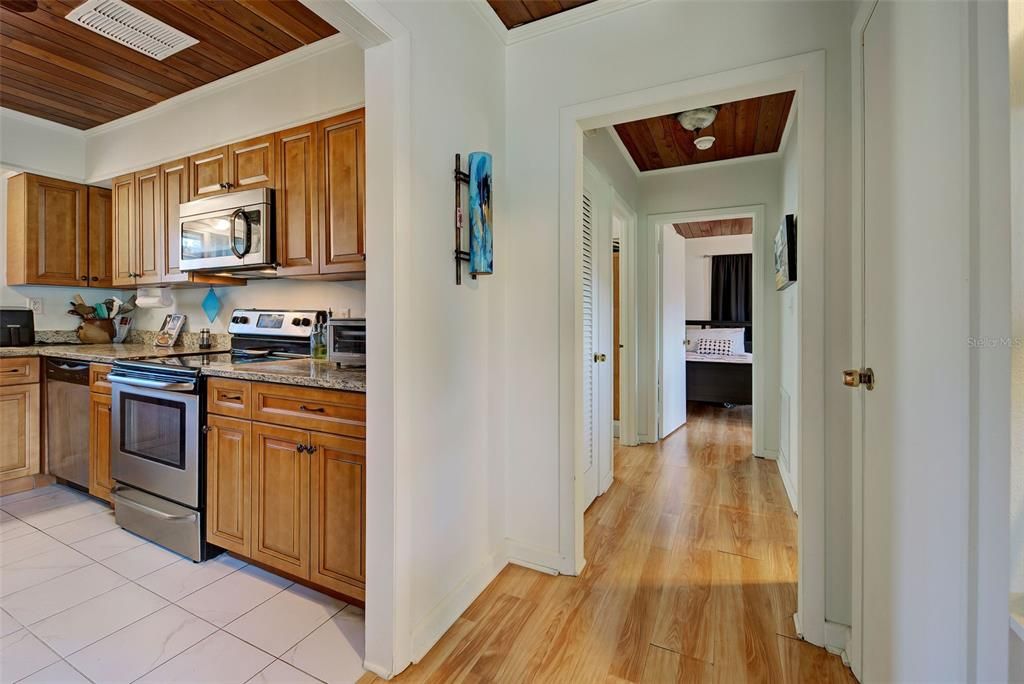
left=7, top=173, right=89, bottom=287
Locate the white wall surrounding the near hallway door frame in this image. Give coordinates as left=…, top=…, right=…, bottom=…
left=507, top=1, right=852, bottom=622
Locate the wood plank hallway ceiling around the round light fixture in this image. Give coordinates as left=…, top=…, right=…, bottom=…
left=615, top=90, right=795, bottom=171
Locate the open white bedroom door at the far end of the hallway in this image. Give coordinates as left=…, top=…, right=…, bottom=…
left=658, top=223, right=686, bottom=439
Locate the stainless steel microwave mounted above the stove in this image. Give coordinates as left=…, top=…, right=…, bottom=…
left=178, top=189, right=275, bottom=270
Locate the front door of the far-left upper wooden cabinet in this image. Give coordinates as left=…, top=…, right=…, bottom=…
left=25, top=174, right=89, bottom=287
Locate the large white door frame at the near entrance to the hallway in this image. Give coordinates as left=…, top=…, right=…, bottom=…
left=558, top=50, right=825, bottom=645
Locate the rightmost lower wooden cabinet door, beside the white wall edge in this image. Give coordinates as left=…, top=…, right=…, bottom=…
left=309, top=432, right=367, bottom=599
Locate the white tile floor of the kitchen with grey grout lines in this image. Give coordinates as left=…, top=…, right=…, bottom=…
left=0, top=485, right=364, bottom=684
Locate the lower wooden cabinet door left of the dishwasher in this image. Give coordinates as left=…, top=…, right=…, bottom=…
left=0, top=385, right=39, bottom=481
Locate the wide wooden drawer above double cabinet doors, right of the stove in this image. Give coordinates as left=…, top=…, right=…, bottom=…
left=252, top=382, right=367, bottom=438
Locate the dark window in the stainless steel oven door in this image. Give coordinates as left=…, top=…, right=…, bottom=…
left=120, top=393, right=186, bottom=470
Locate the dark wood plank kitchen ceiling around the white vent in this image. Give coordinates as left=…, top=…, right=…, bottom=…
left=0, top=0, right=338, bottom=129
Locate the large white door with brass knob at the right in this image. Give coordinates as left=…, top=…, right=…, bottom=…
left=860, top=1, right=971, bottom=682
